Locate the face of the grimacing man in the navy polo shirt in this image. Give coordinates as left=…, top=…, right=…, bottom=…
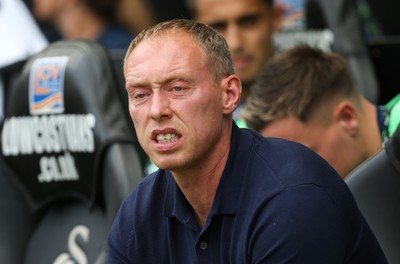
left=124, top=32, right=233, bottom=170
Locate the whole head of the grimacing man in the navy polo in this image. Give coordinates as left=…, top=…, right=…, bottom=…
left=124, top=20, right=241, bottom=173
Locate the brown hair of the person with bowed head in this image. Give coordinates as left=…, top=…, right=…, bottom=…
left=242, top=45, right=361, bottom=131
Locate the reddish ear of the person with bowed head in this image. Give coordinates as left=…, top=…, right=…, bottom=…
left=334, top=101, right=360, bottom=137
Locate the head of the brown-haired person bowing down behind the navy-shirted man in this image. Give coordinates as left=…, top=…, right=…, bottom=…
left=242, top=45, right=381, bottom=176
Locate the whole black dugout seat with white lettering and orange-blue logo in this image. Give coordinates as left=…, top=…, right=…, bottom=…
left=0, top=40, right=143, bottom=264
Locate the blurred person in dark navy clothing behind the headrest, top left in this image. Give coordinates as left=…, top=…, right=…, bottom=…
left=32, top=0, right=134, bottom=49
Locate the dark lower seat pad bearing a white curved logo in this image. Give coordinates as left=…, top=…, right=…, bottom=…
left=24, top=203, right=107, bottom=264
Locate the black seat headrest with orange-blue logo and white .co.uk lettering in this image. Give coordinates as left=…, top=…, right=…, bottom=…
left=1, top=40, right=132, bottom=212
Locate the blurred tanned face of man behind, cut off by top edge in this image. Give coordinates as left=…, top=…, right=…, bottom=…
left=195, top=0, right=279, bottom=89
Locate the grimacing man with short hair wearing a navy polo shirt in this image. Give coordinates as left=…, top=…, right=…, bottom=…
left=108, top=20, right=387, bottom=264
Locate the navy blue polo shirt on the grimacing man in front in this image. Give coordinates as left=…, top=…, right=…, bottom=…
left=108, top=125, right=387, bottom=264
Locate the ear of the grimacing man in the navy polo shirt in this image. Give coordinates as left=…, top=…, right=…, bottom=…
left=222, top=75, right=242, bottom=114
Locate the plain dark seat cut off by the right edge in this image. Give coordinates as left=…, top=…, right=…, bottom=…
left=345, top=126, right=400, bottom=263
